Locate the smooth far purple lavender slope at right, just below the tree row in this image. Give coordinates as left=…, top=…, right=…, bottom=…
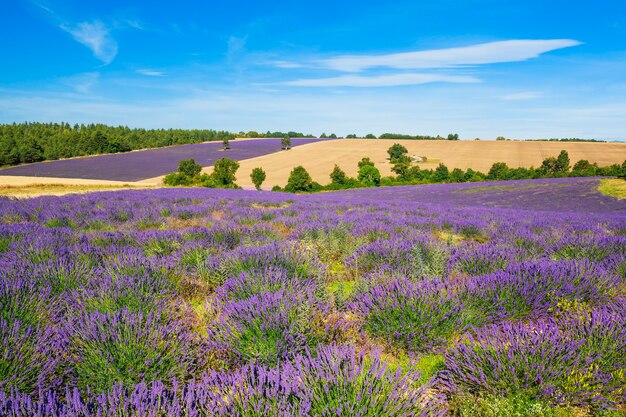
left=316, top=178, right=626, bottom=214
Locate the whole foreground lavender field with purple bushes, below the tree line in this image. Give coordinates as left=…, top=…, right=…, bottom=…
left=0, top=177, right=626, bottom=417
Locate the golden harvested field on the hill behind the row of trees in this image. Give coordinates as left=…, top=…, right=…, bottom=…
left=229, top=139, right=626, bottom=187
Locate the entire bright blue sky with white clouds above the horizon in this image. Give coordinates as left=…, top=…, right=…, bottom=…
left=0, top=0, right=626, bottom=139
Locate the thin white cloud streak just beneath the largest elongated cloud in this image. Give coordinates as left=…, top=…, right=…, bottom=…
left=281, top=74, right=480, bottom=87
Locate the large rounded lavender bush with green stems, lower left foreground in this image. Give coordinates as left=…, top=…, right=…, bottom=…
left=68, top=309, right=198, bottom=393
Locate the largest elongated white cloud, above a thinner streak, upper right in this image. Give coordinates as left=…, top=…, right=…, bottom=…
left=313, top=39, right=580, bottom=72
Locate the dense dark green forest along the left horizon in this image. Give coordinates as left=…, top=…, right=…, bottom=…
left=0, top=122, right=235, bottom=166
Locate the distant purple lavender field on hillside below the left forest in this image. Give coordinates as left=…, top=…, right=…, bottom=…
left=0, top=138, right=323, bottom=181
